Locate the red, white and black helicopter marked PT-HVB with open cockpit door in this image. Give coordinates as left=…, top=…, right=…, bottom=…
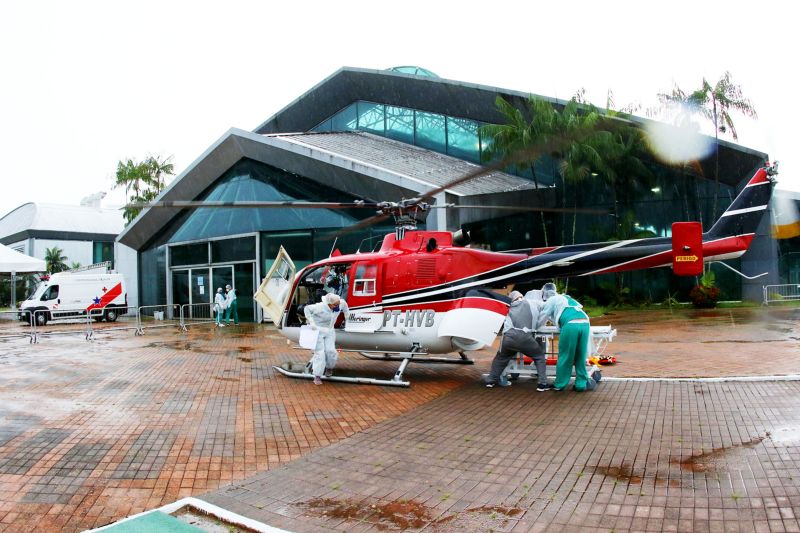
left=247, top=164, right=777, bottom=386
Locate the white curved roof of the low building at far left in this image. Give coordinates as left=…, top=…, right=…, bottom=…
left=0, top=202, right=125, bottom=242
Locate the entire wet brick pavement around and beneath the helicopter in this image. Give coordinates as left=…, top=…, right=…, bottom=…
left=0, top=308, right=800, bottom=531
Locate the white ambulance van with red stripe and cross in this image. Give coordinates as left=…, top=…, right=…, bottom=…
left=19, top=263, right=128, bottom=326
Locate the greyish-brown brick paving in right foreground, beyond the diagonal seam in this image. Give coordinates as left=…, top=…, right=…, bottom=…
left=206, top=382, right=800, bottom=532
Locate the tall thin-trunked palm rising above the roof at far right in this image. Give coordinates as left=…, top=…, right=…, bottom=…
left=658, top=71, right=758, bottom=220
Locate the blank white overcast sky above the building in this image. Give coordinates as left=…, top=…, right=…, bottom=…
left=0, top=0, right=800, bottom=216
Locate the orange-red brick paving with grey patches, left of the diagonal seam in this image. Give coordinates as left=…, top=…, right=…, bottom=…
left=0, top=326, right=477, bottom=531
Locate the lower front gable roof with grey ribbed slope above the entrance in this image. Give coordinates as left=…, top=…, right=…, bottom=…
left=118, top=128, right=535, bottom=249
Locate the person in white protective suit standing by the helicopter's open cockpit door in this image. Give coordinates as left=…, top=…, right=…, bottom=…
left=303, top=293, right=349, bottom=385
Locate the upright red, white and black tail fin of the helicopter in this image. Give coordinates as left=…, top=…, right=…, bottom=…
left=706, top=166, right=777, bottom=240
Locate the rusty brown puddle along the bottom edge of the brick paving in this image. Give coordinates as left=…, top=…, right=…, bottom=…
left=297, top=498, right=524, bottom=531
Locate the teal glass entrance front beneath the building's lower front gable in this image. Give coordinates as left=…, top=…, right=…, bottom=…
left=139, top=160, right=391, bottom=321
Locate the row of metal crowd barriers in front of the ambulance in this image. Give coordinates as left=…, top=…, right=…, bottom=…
left=0, top=303, right=222, bottom=344
